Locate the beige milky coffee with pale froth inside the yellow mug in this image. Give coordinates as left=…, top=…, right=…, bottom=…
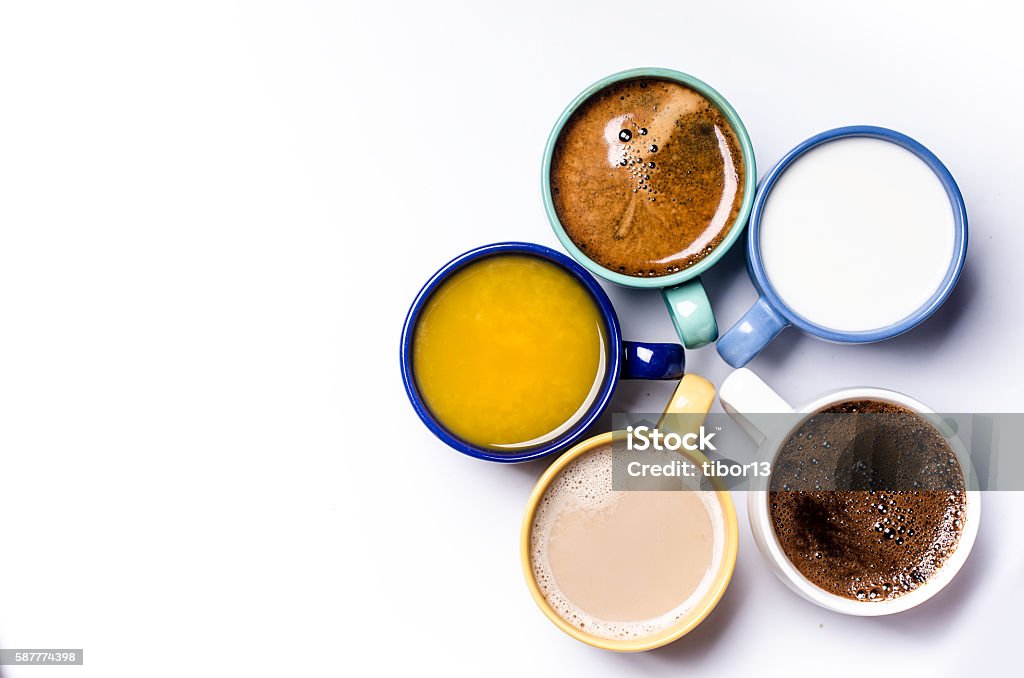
left=530, top=444, right=725, bottom=639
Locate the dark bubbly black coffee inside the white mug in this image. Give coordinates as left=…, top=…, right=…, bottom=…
left=769, top=400, right=967, bottom=601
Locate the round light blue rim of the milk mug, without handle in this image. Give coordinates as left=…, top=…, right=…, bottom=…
left=746, top=125, right=968, bottom=343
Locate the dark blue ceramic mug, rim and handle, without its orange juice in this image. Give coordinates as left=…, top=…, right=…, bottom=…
left=399, top=242, right=684, bottom=463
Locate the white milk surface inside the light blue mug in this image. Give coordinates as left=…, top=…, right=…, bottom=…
left=760, top=137, right=954, bottom=332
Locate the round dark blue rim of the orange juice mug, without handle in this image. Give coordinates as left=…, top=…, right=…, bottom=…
left=399, top=241, right=623, bottom=463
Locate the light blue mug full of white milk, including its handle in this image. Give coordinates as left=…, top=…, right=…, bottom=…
left=717, top=126, right=968, bottom=368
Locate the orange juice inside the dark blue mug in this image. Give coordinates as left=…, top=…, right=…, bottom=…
left=413, top=254, right=608, bottom=452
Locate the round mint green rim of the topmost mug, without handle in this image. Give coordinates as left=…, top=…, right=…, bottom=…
left=541, top=67, right=757, bottom=289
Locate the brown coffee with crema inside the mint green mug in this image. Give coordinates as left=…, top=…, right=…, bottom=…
left=550, top=78, right=744, bottom=278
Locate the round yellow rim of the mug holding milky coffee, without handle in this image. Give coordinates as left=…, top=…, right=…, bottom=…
left=519, top=431, right=739, bottom=652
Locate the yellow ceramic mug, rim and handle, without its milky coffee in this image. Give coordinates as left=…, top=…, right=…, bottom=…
left=519, top=375, right=739, bottom=652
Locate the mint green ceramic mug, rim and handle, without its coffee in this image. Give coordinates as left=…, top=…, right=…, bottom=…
left=541, top=68, right=757, bottom=348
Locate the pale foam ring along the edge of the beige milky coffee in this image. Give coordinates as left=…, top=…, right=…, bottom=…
left=529, top=446, right=725, bottom=640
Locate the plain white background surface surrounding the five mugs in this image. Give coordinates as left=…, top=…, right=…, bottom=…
left=0, top=0, right=1024, bottom=678
